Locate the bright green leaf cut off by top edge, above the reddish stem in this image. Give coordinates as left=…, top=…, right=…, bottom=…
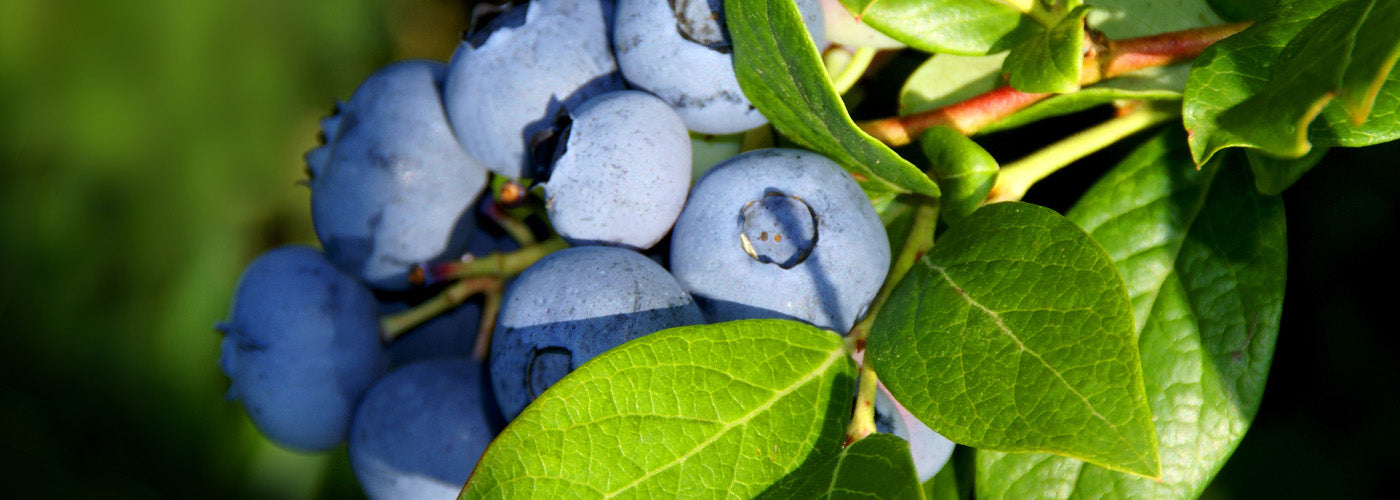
left=840, top=0, right=1042, bottom=56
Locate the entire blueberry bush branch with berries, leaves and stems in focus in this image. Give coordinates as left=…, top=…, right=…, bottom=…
left=223, top=0, right=1400, bottom=499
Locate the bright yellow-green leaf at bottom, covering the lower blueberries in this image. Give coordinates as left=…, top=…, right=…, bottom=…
left=462, top=319, right=855, bottom=499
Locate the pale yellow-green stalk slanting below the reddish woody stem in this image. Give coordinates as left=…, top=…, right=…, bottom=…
left=986, top=104, right=1179, bottom=203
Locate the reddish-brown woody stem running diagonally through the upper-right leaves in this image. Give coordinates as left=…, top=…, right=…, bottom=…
left=858, top=22, right=1250, bottom=146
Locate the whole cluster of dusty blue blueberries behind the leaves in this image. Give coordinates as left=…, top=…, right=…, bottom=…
left=218, top=0, right=952, bottom=499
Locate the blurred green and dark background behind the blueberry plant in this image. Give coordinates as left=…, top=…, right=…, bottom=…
left=0, top=0, right=1400, bottom=499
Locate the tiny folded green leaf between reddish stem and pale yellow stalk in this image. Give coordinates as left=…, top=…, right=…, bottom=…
left=920, top=126, right=998, bottom=221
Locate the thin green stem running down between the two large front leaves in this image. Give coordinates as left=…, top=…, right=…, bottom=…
left=846, top=196, right=938, bottom=445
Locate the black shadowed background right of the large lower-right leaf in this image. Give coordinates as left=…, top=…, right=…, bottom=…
left=1205, top=143, right=1400, bottom=499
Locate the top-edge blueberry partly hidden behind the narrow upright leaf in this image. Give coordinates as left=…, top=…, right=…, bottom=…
left=613, top=0, right=825, bottom=134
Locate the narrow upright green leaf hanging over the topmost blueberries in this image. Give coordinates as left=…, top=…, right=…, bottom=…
left=725, top=0, right=938, bottom=197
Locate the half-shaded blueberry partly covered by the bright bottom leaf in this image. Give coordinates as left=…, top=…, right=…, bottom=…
left=490, top=246, right=704, bottom=419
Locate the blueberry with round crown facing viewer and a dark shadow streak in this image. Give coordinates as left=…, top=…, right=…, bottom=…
left=671, top=148, right=889, bottom=333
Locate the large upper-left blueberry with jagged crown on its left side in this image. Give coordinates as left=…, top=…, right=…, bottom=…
left=307, top=60, right=486, bottom=290
